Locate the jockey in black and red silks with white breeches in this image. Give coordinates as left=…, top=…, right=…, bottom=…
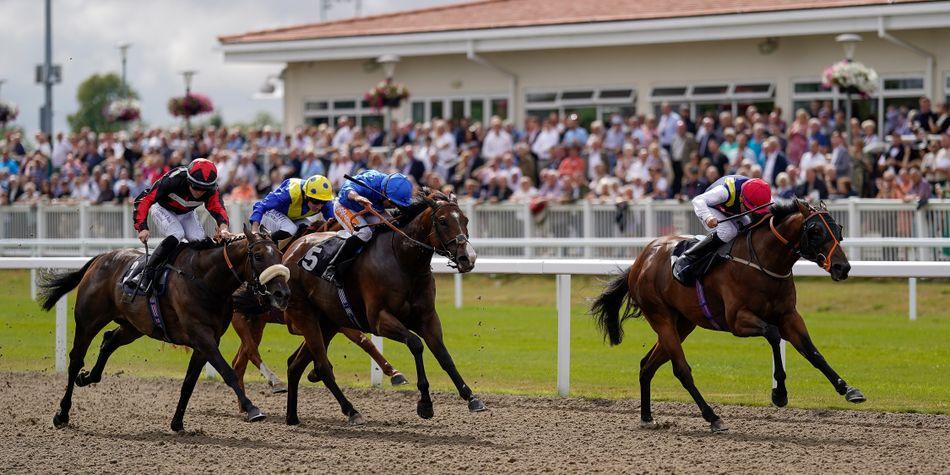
left=133, top=158, right=231, bottom=292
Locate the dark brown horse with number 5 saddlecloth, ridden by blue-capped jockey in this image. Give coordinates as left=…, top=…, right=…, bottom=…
left=274, top=188, right=486, bottom=424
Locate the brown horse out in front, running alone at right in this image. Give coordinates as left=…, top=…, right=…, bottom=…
left=591, top=200, right=865, bottom=432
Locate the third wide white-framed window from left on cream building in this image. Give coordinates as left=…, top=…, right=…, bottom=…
left=525, top=87, right=637, bottom=129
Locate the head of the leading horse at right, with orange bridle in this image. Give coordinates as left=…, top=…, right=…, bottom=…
left=797, top=200, right=851, bottom=281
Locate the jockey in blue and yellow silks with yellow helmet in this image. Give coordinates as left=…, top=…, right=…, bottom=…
left=251, top=175, right=333, bottom=242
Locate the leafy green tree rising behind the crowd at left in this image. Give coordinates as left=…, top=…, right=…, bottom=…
left=66, top=73, right=139, bottom=132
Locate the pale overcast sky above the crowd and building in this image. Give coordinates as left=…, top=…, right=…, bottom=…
left=0, top=0, right=458, bottom=135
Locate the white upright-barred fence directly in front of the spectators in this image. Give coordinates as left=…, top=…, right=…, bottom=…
left=0, top=199, right=950, bottom=261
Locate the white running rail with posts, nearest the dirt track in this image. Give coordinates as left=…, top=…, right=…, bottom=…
left=0, top=257, right=950, bottom=396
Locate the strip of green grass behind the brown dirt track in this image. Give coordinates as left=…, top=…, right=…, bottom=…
left=0, top=271, right=950, bottom=414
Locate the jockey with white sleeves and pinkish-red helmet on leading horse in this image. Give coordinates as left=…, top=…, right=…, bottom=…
left=673, top=175, right=772, bottom=282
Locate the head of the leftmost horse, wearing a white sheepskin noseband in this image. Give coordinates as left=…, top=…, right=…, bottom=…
left=244, top=224, right=290, bottom=310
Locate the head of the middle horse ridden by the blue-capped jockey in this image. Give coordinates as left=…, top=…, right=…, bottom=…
left=421, top=192, right=477, bottom=274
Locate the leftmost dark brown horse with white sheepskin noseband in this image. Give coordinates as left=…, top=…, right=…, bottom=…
left=41, top=227, right=290, bottom=431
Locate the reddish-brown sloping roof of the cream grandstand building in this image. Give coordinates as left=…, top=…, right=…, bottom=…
left=218, top=0, right=919, bottom=45
